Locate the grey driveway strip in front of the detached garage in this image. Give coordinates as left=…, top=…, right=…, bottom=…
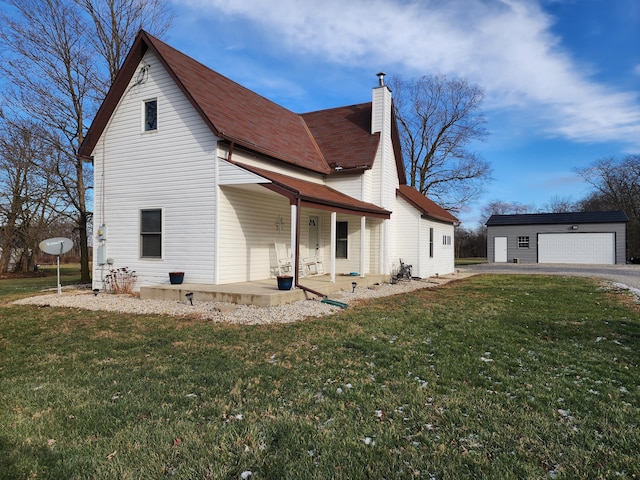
left=460, top=263, right=640, bottom=289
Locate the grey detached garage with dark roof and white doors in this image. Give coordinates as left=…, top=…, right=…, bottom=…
left=486, top=211, right=629, bottom=265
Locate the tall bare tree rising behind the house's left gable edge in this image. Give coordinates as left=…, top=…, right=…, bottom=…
left=0, top=0, right=169, bottom=282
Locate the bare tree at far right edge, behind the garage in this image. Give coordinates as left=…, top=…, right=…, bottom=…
left=577, top=154, right=640, bottom=259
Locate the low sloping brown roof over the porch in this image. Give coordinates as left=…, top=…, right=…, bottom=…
left=236, top=163, right=391, bottom=219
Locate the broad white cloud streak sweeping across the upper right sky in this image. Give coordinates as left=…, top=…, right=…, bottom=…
left=179, top=0, right=640, bottom=146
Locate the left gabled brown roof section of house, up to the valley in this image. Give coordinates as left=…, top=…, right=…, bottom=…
left=80, top=31, right=330, bottom=173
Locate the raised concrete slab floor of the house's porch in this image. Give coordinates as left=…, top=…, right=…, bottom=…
left=140, top=275, right=390, bottom=307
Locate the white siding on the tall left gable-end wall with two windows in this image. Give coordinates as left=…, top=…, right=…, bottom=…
left=93, top=53, right=217, bottom=288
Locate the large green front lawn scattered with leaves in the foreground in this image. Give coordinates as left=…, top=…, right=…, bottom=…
left=0, top=275, right=640, bottom=480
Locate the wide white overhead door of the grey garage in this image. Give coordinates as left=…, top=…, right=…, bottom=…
left=538, top=233, right=616, bottom=265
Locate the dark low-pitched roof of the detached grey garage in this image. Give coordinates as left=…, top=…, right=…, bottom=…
left=485, top=210, right=629, bottom=227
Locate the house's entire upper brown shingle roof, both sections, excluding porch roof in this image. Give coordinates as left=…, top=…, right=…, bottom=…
left=79, top=31, right=406, bottom=184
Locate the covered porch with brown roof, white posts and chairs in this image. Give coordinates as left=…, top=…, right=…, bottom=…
left=218, top=161, right=390, bottom=286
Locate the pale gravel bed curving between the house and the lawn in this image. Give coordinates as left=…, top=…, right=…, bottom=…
left=13, top=275, right=462, bottom=325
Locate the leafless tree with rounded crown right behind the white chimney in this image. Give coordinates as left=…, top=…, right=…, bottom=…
left=391, top=75, right=491, bottom=211
